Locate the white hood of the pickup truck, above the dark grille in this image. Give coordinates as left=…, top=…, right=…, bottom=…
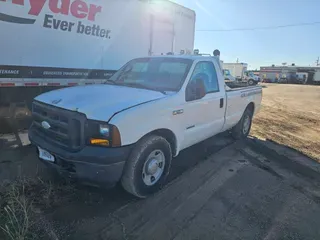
left=35, top=84, right=166, bottom=121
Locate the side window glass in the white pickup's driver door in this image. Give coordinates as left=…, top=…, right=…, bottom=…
left=190, top=62, right=219, bottom=93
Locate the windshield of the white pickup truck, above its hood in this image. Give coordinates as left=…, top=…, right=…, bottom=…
left=110, top=57, right=192, bottom=91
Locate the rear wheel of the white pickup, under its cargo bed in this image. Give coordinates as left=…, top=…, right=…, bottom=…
left=232, top=107, right=253, bottom=140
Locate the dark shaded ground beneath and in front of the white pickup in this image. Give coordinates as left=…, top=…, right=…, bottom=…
left=0, top=134, right=320, bottom=240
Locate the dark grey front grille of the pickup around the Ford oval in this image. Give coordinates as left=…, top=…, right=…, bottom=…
left=32, top=102, right=86, bottom=150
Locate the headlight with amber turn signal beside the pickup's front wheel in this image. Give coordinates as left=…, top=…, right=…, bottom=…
left=86, top=120, right=121, bottom=147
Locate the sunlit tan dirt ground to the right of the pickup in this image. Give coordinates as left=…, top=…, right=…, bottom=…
left=251, top=84, right=320, bottom=162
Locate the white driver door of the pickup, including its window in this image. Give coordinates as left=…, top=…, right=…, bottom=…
left=182, top=61, right=225, bottom=148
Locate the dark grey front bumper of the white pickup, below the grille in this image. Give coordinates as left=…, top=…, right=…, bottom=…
left=29, top=128, right=132, bottom=187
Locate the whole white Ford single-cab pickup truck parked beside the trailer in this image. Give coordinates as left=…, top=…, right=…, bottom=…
left=29, top=55, right=262, bottom=198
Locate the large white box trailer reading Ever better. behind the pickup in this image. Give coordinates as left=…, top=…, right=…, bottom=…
left=0, top=0, right=195, bottom=131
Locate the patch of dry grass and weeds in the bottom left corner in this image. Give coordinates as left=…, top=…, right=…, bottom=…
left=0, top=178, right=74, bottom=240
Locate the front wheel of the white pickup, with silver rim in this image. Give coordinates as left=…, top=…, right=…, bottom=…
left=121, top=135, right=172, bottom=198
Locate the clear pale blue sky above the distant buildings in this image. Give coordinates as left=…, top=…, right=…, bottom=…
left=173, top=0, right=320, bottom=69
